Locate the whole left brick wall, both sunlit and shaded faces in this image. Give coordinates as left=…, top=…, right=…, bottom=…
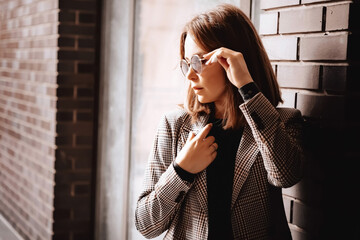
left=0, top=0, right=101, bottom=240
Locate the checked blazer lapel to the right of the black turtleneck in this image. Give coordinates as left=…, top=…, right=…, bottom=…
left=231, top=124, right=258, bottom=209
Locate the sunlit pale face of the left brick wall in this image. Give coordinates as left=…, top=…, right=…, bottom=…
left=0, top=0, right=58, bottom=240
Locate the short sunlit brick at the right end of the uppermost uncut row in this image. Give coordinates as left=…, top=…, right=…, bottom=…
left=325, top=4, right=350, bottom=31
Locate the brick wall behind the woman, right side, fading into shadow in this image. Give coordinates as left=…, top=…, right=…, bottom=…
left=259, top=0, right=360, bottom=239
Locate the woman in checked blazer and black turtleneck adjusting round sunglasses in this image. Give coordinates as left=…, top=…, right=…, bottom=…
left=135, top=5, right=303, bottom=239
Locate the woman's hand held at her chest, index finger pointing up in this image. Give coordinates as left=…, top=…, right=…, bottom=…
left=175, top=123, right=218, bottom=174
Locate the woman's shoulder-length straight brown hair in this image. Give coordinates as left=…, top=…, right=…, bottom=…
left=180, top=4, right=282, bottom=129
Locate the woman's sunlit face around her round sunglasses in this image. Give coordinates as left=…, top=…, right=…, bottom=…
left=185, top=35, right=226, bottom=106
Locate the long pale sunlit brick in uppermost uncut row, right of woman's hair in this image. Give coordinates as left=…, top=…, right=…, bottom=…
left=279, top=7, right=323, bottom=33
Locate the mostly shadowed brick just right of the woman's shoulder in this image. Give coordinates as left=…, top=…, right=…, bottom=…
left=296, top=93, right=345, bottom=123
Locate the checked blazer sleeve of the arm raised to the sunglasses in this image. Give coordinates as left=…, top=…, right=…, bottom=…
left=240, top=93, right=304, bottom=187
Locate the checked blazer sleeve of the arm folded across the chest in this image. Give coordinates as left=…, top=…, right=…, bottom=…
left=135, top=112, right=191, bottom=238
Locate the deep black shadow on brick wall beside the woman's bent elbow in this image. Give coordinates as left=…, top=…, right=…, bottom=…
left=300, top=113, right=360, bottom=239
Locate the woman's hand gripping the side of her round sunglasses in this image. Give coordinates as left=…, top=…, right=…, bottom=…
left=203, top=47, right=253, bottom=88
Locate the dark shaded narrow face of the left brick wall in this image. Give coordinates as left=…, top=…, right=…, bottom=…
left=53, top=0, right=101, bottom=240
